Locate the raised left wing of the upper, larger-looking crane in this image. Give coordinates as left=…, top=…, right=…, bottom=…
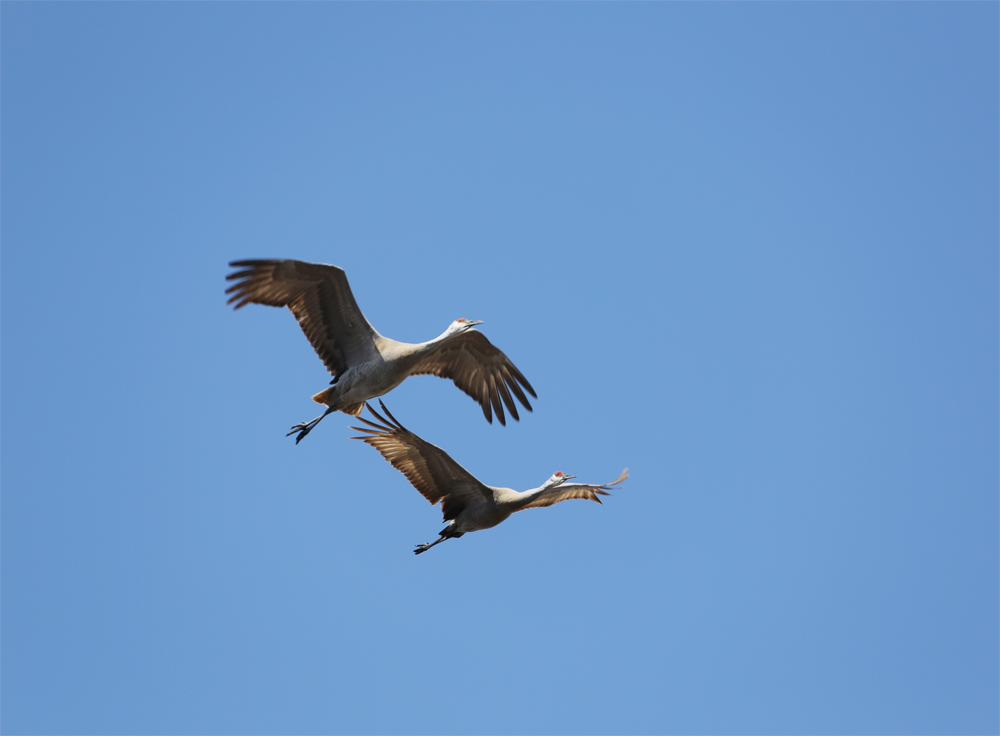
left=226, top=260, right=378, bottom=376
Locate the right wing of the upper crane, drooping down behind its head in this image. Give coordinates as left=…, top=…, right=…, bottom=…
left=411, top=330, right=538, bottom=425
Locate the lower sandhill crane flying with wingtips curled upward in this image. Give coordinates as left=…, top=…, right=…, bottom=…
left=351, top=399, right=628, bottom=555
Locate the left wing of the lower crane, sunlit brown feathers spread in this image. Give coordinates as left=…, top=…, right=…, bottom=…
left=351, top=399, right=493, bottom=521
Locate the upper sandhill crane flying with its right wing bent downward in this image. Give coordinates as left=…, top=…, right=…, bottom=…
left=226, top=260, right=538, bottom=444
